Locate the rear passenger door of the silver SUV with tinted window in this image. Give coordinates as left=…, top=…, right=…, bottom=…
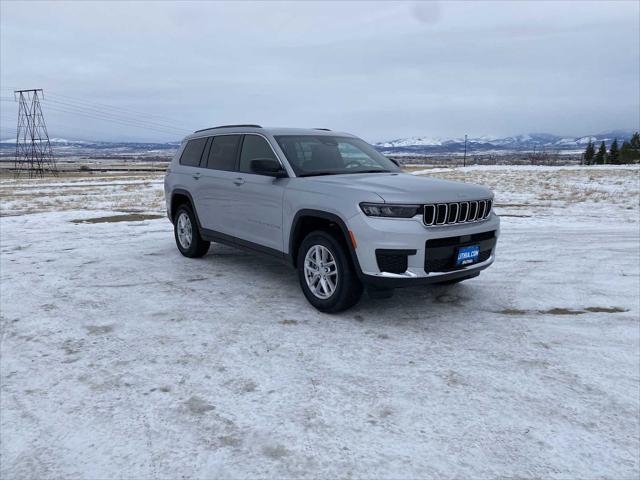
left=197, top=135, right=242, bottom=236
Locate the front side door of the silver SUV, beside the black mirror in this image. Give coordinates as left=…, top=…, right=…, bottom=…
left=232, top=134, right=289, bottom=252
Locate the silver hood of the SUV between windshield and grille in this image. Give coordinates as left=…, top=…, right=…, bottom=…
left=305, top=173, right=493, bottom=204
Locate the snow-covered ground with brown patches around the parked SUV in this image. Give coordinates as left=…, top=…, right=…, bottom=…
left=0, top=167, right=640, bottom=479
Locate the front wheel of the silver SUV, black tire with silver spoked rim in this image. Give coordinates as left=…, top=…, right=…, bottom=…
left=297, top=230, right=363, bottom=313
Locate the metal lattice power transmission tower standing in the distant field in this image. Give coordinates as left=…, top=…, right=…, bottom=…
left=13, top=88, right=58, bottom=177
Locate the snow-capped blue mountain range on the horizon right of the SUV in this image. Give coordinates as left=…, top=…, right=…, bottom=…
left=374, top=130, right=633, bottom=155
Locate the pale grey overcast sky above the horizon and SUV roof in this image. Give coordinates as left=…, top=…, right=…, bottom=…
left=0, top=1, right=640, bottom=141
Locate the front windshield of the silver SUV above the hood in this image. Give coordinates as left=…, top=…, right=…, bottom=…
left=275, top=135, right=400, bottom=177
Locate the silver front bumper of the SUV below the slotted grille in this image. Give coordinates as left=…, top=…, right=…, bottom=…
left=348, top=213, right=500, bottom=288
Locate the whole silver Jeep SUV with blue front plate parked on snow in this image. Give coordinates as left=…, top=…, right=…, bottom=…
left=164, top=125, right=500, bottom=312
